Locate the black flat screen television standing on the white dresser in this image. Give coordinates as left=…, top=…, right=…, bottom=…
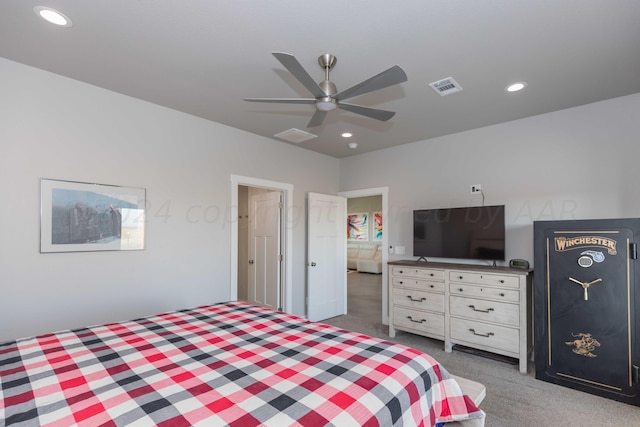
left=413, top=205, right=505, bottom=261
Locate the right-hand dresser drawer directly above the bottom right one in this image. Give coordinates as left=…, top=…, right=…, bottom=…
left=449, top=295, right=520, bottom=327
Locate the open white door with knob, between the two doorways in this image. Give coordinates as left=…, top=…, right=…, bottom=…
left=307, top=193, right=347, bottom=321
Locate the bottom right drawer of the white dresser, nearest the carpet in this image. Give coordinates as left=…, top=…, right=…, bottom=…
left=451, top=317, right=520, bottom=354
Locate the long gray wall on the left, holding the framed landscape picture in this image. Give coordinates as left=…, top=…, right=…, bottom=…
left=0, top=58, right=339, bottom=342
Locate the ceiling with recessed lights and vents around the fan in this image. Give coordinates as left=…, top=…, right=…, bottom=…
left=0, top=0, right=640, bottom=158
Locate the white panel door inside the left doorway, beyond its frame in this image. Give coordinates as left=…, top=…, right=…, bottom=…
left=248, top=191, right=282, bottom=309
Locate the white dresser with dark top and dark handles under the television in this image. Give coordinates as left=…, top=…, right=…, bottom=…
left=389, top=261, right=533, bottom=373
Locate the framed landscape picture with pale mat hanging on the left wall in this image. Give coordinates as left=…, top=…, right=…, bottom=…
left=40, top=178, right=146, bottom=253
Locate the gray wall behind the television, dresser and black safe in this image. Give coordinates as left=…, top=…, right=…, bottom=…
left=340, top=95, right=640, bottom=263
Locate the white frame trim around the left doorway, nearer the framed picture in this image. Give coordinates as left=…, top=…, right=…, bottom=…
left=229, top=175, right=293, bottom=313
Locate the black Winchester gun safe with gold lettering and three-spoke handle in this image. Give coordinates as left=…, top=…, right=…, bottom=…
left=534, top=218, right=640, bottom=406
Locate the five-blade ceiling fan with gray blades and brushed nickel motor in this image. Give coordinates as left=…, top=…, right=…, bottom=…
left=244, top=52, right=407, bottom=127
